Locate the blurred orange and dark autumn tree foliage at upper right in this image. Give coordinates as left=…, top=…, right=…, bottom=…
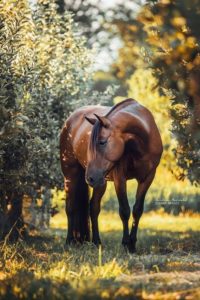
left=109, top=0, right=200, bottom=183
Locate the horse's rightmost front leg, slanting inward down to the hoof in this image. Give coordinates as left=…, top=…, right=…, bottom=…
left=129, top=171, right=155, bottom=253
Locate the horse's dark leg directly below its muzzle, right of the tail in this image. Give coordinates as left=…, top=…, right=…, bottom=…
left=90, top=184, right=106, bottom=246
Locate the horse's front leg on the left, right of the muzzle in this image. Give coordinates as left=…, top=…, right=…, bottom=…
left=114, top=176, right=130, bottom=247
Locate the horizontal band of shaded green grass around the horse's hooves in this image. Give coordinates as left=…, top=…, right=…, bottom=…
left=17, top=225, right=200, bottom=271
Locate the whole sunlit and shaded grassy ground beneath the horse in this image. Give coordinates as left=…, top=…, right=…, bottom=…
left=0, top=211, right=200, bottom=299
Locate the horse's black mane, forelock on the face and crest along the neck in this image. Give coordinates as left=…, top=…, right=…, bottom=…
left=89, top=98, right=134, bottom=157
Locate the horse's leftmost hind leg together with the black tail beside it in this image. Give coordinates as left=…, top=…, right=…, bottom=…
left=65, top=164, right=90, bottom=244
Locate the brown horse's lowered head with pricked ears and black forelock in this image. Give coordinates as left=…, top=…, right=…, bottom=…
left=85, top=115, right=124, bottom=187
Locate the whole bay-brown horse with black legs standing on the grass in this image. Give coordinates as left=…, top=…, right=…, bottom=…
left=60, top=99, right=163, bottom=252
